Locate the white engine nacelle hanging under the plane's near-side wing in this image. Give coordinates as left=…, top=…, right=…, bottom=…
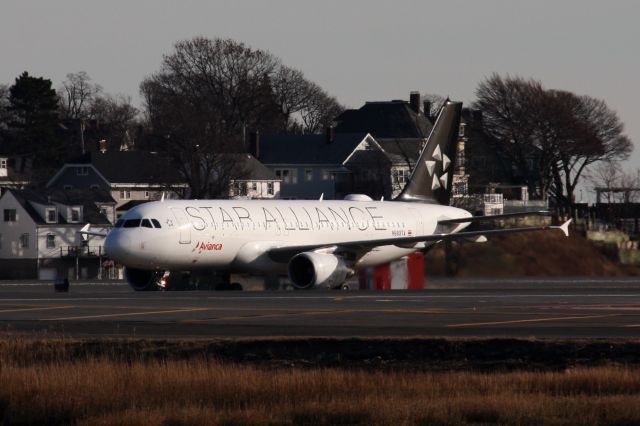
left=289, top=252, right=353, bottom=289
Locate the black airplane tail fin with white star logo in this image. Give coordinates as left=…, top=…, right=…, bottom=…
left=396, top=100, right=462, bottom=205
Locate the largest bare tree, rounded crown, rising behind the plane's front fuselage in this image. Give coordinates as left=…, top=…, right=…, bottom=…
left=141, top=37, right=283, bottom=198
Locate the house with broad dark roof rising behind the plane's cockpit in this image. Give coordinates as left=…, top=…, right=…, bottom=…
left=47, top=151, right=188, bottom=218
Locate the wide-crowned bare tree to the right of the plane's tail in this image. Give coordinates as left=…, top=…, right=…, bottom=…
left=475, top=74, right=632, bottom=205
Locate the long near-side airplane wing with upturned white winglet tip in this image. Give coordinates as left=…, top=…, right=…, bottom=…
left=268, top=219, right=571, bottom=262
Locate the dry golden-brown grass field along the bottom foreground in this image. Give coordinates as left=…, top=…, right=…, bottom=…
left=0, top=340, right=640, bottom=425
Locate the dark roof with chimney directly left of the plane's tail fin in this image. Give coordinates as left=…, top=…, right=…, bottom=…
left=335, top=101, right=433, bottom=140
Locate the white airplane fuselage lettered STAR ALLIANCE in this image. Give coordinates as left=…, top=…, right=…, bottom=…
left=105, top=200, right=471, bottom=272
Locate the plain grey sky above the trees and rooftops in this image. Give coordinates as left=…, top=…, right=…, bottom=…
left=0, top=0, right=640, bottom=176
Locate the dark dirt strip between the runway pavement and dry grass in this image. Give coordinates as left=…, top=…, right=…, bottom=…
left=0, top=335, right=640, bottom=371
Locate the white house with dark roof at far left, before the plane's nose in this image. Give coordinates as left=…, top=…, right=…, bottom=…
left=0, top=189, right=115, bottom=279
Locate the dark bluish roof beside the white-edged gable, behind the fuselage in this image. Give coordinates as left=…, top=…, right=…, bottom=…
left=260, top=132, right=367, bottom=164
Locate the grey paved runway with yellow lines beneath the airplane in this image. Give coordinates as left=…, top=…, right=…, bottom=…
left=0, top=279, right=640, bottom=338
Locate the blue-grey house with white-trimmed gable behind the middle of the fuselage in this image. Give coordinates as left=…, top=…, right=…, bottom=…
left=251, top=130, right=390, bottom=199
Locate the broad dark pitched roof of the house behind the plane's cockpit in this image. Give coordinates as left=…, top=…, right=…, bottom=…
left=69, top=151, right=184, bottom=184
